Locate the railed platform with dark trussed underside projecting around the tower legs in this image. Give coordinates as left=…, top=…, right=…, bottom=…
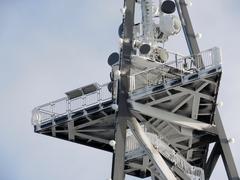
left=32, top=48, right=222, bottom=180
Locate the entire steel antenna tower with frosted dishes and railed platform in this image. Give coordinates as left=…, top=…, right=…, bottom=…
left=32, top=0, right=239, bottom=180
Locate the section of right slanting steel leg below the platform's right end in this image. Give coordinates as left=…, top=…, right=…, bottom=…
left=214, top=108, right=240, bottom=180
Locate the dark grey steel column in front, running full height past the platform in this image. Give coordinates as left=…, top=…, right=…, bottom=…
left=112, top=0, right=135, bottom=180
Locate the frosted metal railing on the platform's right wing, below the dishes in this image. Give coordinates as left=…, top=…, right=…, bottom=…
left=130, top=47, right=222, bottom=92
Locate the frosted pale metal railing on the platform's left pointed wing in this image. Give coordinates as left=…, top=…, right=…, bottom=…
left=31, top=84, right=112, bottom=125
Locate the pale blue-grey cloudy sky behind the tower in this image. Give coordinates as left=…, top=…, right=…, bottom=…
left=0, top=0, right=240, bottom=180
